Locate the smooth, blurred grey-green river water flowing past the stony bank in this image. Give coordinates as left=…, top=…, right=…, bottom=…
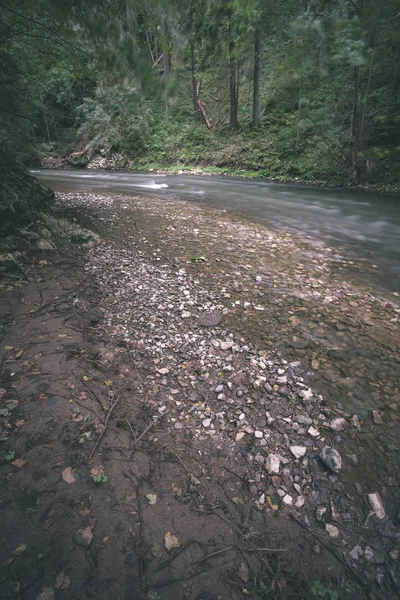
left=32, top=170, right=400, bottom=292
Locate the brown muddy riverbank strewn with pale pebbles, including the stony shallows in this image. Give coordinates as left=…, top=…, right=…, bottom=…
left=0, top=194, right=400, bottom=600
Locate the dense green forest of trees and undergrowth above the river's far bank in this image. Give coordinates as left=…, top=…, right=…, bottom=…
left=0, top=0, right=400, bottom=190
